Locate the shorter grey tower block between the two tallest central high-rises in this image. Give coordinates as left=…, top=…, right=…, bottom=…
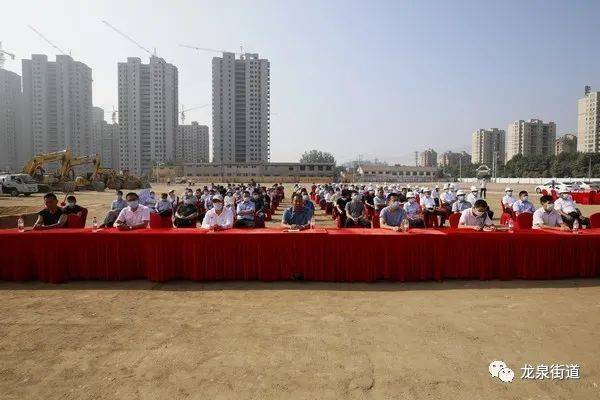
left=175, top=121, right=209, bottom=163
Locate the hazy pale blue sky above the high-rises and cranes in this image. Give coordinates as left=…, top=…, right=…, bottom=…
left=0, top=0, right=600, bottom=163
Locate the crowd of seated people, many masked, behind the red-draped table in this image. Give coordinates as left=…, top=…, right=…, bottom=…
left=33, top=182, right=590, bottom=231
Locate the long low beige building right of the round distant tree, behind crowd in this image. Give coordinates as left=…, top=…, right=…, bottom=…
left=355, top=165, right=437, bottom=182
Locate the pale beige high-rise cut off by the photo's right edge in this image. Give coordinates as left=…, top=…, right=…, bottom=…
left=577, top=86, right=600, bottom=153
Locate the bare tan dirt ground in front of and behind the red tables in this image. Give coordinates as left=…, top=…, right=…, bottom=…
left=0, top=185, right=600, bottom=400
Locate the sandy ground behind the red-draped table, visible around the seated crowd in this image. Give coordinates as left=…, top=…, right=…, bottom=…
left=0, top=183, right=600, bottom=227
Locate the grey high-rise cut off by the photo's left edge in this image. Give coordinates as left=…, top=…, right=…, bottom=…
left=0, top=68, right=25, bottom=171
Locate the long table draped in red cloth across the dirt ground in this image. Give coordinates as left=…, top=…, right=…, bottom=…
left=0, top=229, right=600, bottom=283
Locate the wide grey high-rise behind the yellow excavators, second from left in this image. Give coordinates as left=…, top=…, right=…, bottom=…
left=22, top=54, right=92, bottom=158
